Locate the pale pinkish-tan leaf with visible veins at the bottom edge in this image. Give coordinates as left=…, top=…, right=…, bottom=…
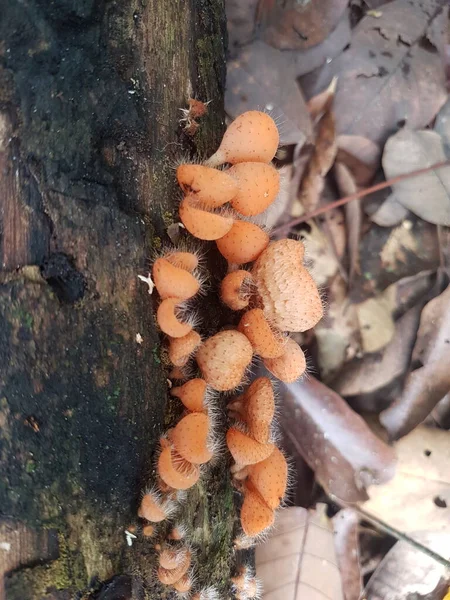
left=256, top=504, right=343, bottom=600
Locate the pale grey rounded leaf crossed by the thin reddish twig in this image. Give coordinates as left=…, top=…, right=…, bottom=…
left=383, top=129, right=450, bottom=225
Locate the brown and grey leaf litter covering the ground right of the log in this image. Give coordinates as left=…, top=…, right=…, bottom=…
left=225, top=0, right=450, bottom=600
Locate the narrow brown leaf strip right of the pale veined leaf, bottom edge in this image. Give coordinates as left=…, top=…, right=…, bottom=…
left=332, top=508, right=362, bottom=600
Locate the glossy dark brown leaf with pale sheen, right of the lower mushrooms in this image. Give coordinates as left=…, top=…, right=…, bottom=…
left=280, top=377, right=395, bottom=503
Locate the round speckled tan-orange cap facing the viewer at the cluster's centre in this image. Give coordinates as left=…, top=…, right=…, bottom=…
left=196, top=330, right=253, bottom=392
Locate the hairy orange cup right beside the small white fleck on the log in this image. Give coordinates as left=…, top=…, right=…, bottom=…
left=152, top=258, right=200, bottom=300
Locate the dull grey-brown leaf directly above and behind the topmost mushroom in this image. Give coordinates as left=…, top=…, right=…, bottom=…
left=225, top=41, right=312, bottom=145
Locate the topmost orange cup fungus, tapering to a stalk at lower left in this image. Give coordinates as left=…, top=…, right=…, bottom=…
left=205, top=110, right=280, bottom=167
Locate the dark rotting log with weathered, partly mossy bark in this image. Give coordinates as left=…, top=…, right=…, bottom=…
left=0, top=0, right=235, bottom=600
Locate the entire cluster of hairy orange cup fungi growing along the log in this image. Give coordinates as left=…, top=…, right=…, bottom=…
left=138, top=111, right=322, bottom=600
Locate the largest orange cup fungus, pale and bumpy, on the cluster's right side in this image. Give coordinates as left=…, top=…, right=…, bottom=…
left=252, top=240, right=323, bottom=331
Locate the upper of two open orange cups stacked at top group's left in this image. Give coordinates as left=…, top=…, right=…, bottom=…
left=177, top=164, right=238, bottom=208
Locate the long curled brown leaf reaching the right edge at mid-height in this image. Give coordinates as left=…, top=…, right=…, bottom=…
left=380, top=286, right=450, bottom=439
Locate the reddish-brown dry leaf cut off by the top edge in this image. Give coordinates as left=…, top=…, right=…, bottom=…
left=263, top=0, right=348, bottom=50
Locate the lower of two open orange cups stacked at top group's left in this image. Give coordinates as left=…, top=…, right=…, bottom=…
left=178, top=196, right=233, bottom=240
